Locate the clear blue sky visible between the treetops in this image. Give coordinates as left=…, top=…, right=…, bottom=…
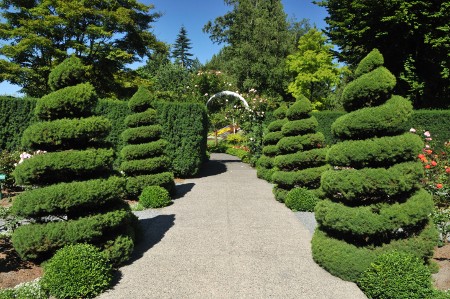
left=0, top=0, right=327, bottom=96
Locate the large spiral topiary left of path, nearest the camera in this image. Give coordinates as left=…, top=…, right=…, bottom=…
left=12, top=59, right=137, bottom=264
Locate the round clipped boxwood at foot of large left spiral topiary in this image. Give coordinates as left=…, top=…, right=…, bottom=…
left=42, top=244, right=112, bottom=298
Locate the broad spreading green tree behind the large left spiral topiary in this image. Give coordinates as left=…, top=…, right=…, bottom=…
left=0, top=0, right=161, bottom=97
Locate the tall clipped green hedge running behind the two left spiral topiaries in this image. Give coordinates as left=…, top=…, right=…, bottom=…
left=0, top=97, right=207, bottom=177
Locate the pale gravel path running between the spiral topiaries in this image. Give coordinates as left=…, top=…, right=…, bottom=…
left=99, top=154, right=366, bottom=299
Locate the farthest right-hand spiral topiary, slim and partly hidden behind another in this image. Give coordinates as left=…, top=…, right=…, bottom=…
left=256, top=106, right=288, bottom=182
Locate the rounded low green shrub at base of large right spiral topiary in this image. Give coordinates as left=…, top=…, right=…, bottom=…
left=358, top=251, right=432, bottom=299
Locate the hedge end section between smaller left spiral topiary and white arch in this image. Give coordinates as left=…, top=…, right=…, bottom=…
left=157, top=102, right=208, bottom=177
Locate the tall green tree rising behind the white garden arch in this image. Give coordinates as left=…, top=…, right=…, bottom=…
left=203, top=0, right=294, bottom=101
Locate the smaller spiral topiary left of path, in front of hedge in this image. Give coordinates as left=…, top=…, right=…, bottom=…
left=120, top=87, right=175, bottom=198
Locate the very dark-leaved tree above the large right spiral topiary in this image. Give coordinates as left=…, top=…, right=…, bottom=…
left=315, top=0, right=450, bottom=108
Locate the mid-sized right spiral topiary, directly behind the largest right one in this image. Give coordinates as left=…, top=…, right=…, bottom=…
left=272, top=97, right=328, bottom=202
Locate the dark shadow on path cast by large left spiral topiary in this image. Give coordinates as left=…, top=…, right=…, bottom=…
left=128, top=215, right=175, bottom=264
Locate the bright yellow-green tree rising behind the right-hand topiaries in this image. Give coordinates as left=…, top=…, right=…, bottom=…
left=287, top=28, right=341, bottom=109
